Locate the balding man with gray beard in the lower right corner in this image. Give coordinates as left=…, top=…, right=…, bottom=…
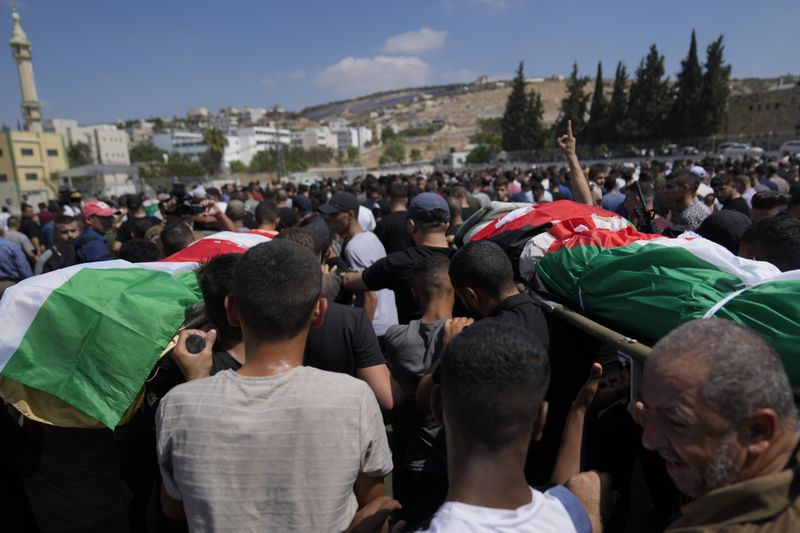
left=633, top=319, right=800, bottom=532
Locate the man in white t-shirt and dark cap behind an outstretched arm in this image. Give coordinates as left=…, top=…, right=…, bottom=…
left=319, top=192, right=397, bottom=337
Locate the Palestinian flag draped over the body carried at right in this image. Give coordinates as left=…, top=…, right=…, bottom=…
left=467, top=200, right=800, bottom=390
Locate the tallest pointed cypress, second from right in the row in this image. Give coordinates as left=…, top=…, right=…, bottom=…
left=670, top=30, right=703, bottom=137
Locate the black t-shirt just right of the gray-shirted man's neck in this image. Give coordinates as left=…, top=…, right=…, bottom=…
left=303, top=302, right=386, bottom=377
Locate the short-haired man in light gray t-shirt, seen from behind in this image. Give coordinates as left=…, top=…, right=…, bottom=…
left=156, top=240, right=391, bottom=531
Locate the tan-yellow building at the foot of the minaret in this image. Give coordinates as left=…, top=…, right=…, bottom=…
left=0, top=131, right=69, bottom=206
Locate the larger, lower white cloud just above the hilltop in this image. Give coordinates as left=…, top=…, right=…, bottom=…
left=314, top=56, right=431, bottom=96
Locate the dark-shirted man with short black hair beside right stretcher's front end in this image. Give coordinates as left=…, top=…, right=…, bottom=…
left=450, top=241, right=550, bottom=349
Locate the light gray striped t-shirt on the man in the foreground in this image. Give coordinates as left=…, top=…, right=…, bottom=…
left=156, top=367, right=392, bottom=531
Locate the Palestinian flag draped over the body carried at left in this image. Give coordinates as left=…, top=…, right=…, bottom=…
left=0, top=232, right=269, bottom=428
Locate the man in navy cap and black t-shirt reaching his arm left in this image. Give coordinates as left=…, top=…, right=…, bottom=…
left=342, top=193, right=450, bottom=324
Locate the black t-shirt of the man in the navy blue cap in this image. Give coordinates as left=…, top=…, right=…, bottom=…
left=362, top=246, right=452, bottom=324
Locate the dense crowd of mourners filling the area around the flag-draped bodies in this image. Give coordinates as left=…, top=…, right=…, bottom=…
left=0, top=132, right=800, bottom=532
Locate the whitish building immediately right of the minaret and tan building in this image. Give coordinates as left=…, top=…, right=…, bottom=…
left=44, top=118, right=131, bottom=165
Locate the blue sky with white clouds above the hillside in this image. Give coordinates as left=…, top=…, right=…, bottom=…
left=0, top=0, right=800, bottom=127
